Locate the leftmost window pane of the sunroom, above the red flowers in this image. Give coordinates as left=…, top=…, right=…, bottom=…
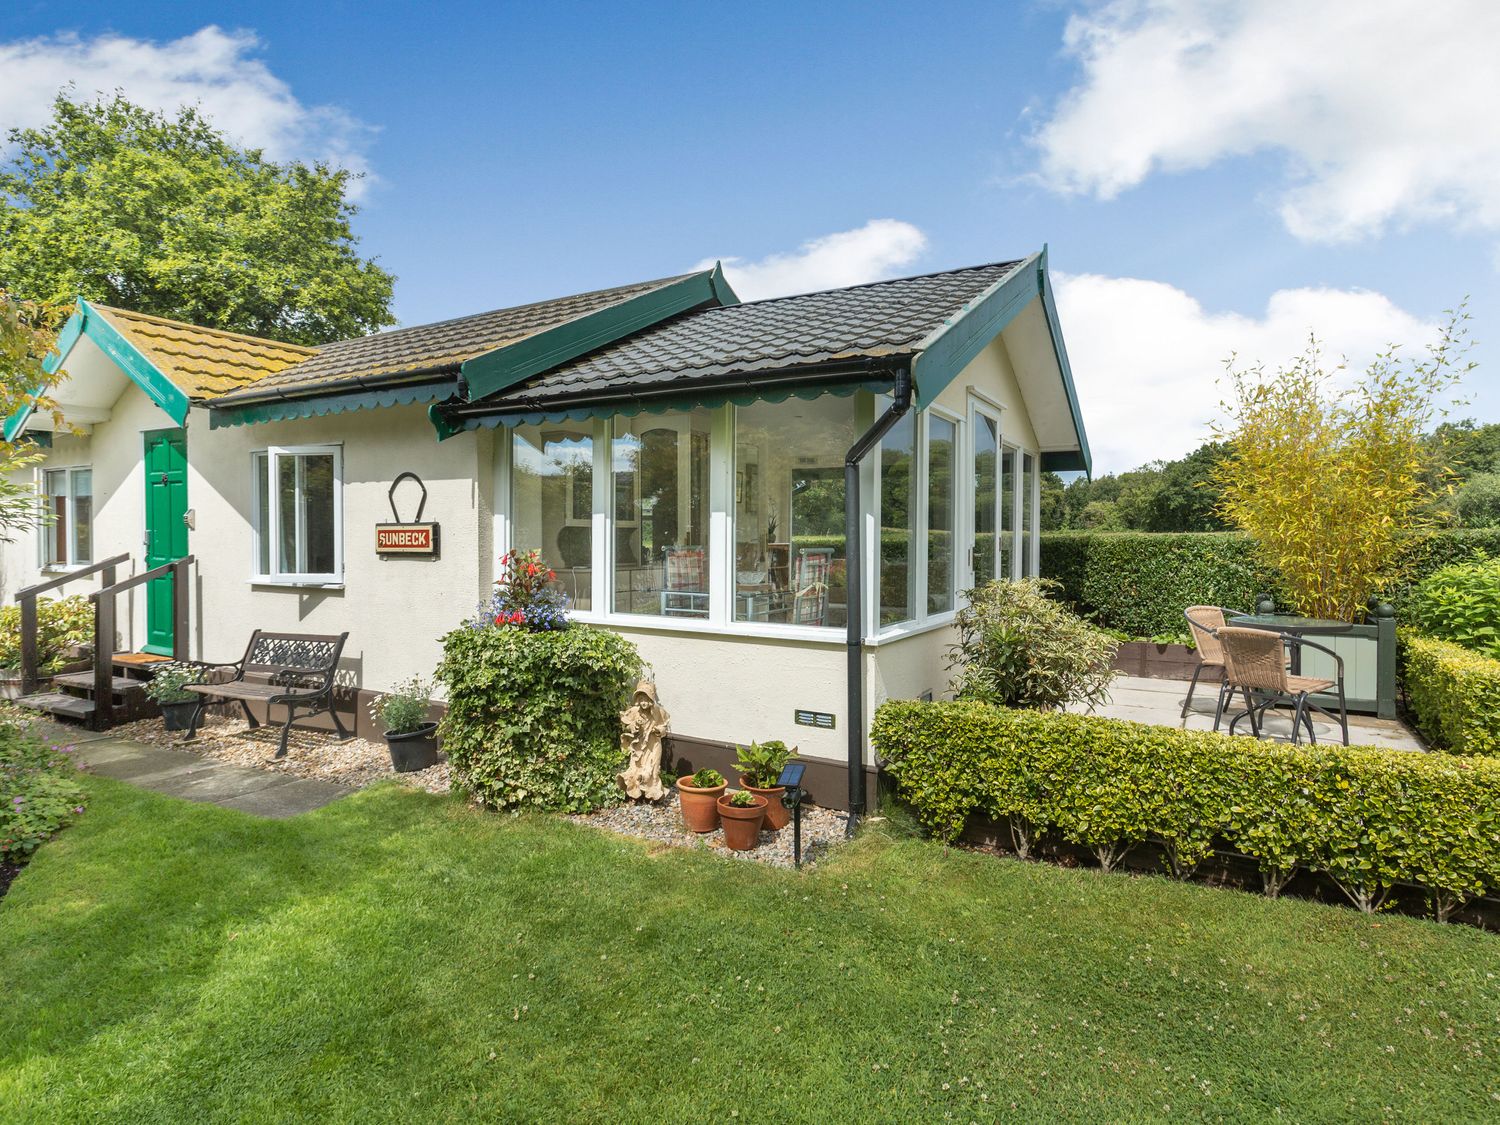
left=510, top=422, right=594, bottom=609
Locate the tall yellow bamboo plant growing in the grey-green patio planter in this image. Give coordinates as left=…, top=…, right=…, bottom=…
left=1214, top=311, right=1473, bottom=621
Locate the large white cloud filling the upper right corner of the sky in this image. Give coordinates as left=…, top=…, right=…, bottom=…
left=1034, top=0, right=1500, bottom=242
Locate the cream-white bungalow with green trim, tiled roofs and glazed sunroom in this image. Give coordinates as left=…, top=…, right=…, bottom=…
left=0, top=251, right=1089, bottom=806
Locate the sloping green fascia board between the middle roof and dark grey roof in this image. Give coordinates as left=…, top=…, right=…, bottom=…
left=461, top=264, right=740, bottom=401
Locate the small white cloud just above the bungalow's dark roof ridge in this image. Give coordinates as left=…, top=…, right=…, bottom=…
left=693, top=219, right=927, bottom=302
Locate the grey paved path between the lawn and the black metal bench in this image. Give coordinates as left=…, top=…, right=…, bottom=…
left=32, top=720, right=354, bottom=818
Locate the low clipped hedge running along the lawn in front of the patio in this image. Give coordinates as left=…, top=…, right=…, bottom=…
left=870, top=702, right=1500, bottom=918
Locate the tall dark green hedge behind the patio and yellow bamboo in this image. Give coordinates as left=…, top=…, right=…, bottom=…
left=1041, top=528, right=1500, bottom=638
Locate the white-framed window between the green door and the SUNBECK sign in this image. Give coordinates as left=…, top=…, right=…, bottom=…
left=251, top=446, right=344, bottom=585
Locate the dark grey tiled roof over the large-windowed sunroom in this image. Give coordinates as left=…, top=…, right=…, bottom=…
left=492, top=261, right=1022, bottom=405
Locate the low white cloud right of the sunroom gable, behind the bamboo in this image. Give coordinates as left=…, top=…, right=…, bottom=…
left=1053, top=275, right=1439, bottom=474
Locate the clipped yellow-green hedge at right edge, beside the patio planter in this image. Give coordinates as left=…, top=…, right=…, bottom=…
left=1401, top=632, right=1500, bottom=755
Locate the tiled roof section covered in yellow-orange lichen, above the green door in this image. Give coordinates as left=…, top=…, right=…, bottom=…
left=92, top=305, right=317, bottom=399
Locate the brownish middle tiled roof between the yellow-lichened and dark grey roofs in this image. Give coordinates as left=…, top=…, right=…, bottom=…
left=225, top=275, right=692, bottom=405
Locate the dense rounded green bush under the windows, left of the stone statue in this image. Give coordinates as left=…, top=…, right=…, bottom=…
left=438, top=626, right=641, bottom=813
